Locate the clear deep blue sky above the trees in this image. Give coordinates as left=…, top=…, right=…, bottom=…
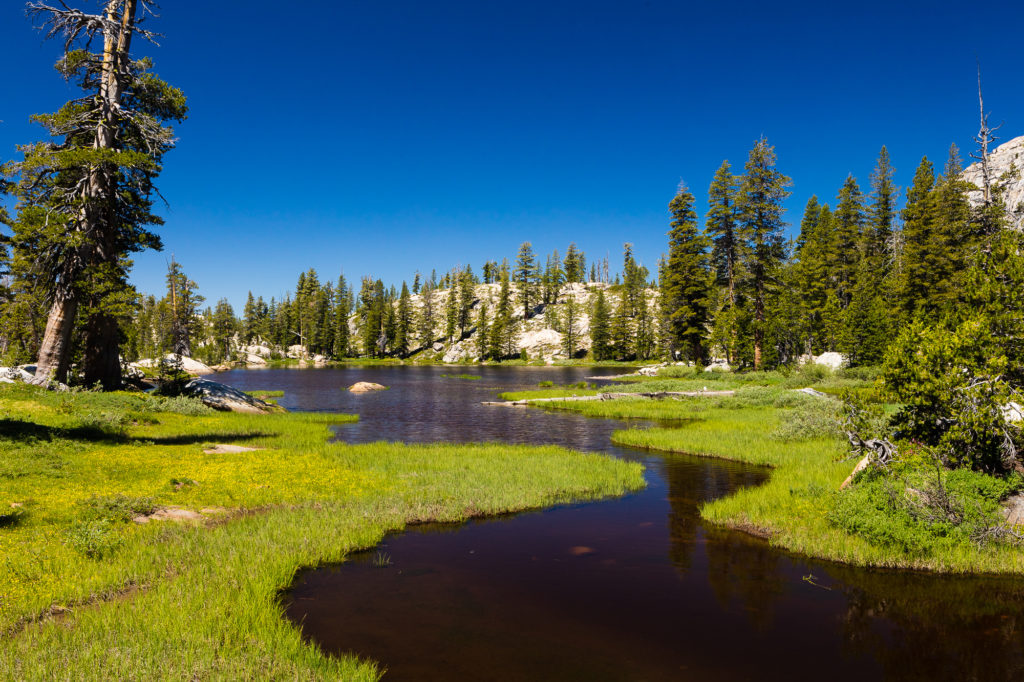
left=0, top=0, right=1024, bottom=312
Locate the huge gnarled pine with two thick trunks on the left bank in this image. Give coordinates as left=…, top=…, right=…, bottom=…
left=5, top=0, right=187, bottom=389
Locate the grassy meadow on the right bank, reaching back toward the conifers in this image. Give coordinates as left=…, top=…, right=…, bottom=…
left=509, top=367, right=1024, bottom=573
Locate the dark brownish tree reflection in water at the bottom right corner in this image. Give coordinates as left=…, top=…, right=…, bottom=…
left=828, top=566, right=1024, bottom=682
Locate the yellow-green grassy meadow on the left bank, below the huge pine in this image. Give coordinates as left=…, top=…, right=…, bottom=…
left=0, top=386, right=643, bottom=680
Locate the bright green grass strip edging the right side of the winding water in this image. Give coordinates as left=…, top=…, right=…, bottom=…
left=512, top=379, right=1024, bottom=573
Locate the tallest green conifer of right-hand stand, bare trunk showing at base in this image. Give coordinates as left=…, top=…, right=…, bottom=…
left=736, top=138, right=791, bottom=369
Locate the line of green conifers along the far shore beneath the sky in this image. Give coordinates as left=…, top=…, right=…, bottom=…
left=0, top=135, right=1016, bottom=368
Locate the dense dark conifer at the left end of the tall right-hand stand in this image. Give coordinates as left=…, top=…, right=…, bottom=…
left=660, top=180, right=712, bottom=364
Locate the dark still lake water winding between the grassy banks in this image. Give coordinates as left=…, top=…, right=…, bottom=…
left=216, top=367, right=1024, bottom=682
